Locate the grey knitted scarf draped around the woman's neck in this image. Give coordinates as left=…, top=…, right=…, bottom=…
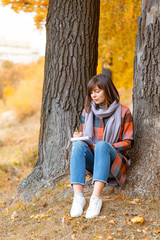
left=83, top=101, right=121, bottom=144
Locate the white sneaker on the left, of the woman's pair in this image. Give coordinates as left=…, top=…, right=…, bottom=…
left=70, top=195, right=86, bottom=217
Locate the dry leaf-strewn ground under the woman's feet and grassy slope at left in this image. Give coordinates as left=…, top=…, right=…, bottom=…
left=0, top=115, right=160, bottom=240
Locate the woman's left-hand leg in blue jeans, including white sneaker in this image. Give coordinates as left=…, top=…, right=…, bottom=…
left=70, top=141, right=94, bottom=217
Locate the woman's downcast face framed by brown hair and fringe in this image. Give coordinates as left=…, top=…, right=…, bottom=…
left=91, top=86, right=106, bottom=104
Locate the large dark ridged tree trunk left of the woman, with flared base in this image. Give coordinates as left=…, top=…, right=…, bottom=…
left=18, top=0, right=100, bottom=200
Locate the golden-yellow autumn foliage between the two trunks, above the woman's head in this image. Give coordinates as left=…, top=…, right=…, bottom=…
left=97, top=0, right=142, bottom=88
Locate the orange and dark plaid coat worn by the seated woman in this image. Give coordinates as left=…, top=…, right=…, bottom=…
left=80, top=105, right=133, bottom=188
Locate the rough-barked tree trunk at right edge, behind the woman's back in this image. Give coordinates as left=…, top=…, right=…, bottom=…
left=103, top=0, right=160, bottom=199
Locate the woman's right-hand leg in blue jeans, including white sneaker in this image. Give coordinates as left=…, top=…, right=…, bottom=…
left=86, top=141, right=117, bottom=218
